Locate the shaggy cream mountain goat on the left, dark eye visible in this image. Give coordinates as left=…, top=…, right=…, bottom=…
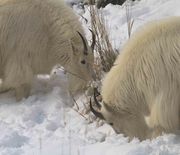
left=0, top=0, right=93, bottom=100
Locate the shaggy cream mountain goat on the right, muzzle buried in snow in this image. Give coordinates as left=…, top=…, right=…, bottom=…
left=90, top=17, right=180, bottom=140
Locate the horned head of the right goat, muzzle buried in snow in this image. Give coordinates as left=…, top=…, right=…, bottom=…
left=90, top=89, right=151, bottom=140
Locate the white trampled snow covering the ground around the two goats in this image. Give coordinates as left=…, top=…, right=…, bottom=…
left=0, top=0, right=180, bottom=155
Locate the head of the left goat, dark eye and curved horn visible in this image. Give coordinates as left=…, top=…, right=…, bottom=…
left=68, top=32, right=95, bottom=94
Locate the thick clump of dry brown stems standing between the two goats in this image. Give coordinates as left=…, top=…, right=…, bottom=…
left=90, top=6, right=118, bottom=80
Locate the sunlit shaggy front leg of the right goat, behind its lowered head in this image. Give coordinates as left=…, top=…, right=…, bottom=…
left=145, top=94, right=180, bottom=136
